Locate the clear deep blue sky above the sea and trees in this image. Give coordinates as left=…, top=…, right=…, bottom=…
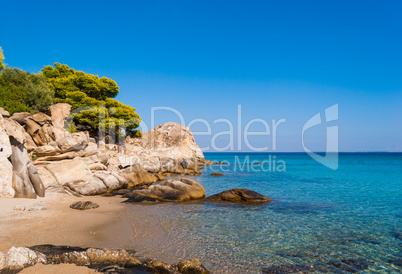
left=0, top=0, right=402, bottom=151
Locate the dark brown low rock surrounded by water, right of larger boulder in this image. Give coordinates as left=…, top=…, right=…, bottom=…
left=205, top=188, right=272, bottom=204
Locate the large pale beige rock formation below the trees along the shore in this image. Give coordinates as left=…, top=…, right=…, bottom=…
left=0, top=103, right=212, bottom=197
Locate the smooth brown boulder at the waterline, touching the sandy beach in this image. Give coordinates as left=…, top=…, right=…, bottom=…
left=123, top=178, right=205, bottom=203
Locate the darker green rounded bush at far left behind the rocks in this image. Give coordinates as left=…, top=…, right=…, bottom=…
left=0, top=67, right=54, bottom=114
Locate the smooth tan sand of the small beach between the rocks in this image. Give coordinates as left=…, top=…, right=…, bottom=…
left=0, top=193, right=130, bottom=252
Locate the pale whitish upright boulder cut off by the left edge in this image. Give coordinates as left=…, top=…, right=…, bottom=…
left=0, top=114, right=15, bottom=197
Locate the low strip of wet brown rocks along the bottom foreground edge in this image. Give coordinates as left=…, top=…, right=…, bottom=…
left=0, top=245, right=209, bottom=274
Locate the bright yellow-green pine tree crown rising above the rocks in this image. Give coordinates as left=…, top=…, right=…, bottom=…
left=42, top=63, right=142, bottom=140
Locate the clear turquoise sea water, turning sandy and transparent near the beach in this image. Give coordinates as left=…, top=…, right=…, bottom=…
left=127, top=153, right=402, bottom=273
